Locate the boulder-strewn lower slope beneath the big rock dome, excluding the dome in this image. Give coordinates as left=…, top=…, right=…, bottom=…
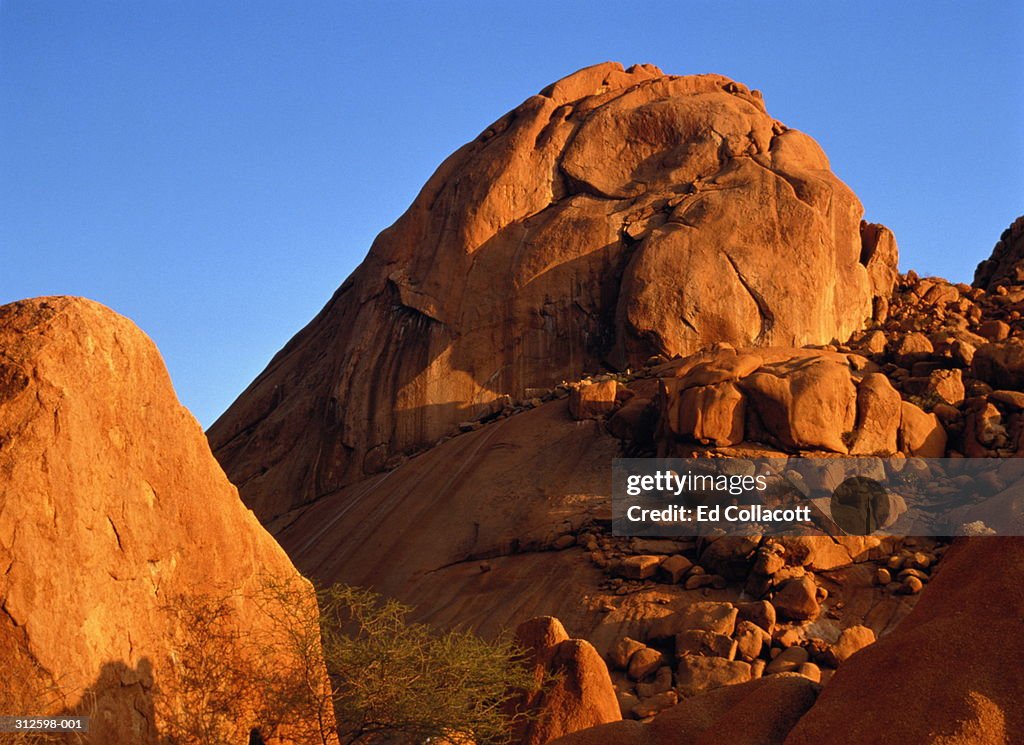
left=256, top=185, right=1024, bottom=745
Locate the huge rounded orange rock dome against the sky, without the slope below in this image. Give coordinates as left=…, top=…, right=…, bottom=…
left=209, top=63, right=896, bottom=520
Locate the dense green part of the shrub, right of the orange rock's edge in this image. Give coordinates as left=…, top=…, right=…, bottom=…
left=319, top=584, right=536, bottom=745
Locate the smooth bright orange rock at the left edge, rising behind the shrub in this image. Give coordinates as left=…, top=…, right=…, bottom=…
left=0, top=298, right=325, bottom=743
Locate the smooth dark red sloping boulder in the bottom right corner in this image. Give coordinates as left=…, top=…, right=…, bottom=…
left=785, top=537, right=1024, bottom=745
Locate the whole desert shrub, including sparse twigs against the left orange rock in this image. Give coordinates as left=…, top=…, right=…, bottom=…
left=158, top=577, right=537, bottom=745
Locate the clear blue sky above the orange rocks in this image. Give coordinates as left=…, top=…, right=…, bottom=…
left=0, top=0, right=1024, bottom=426
